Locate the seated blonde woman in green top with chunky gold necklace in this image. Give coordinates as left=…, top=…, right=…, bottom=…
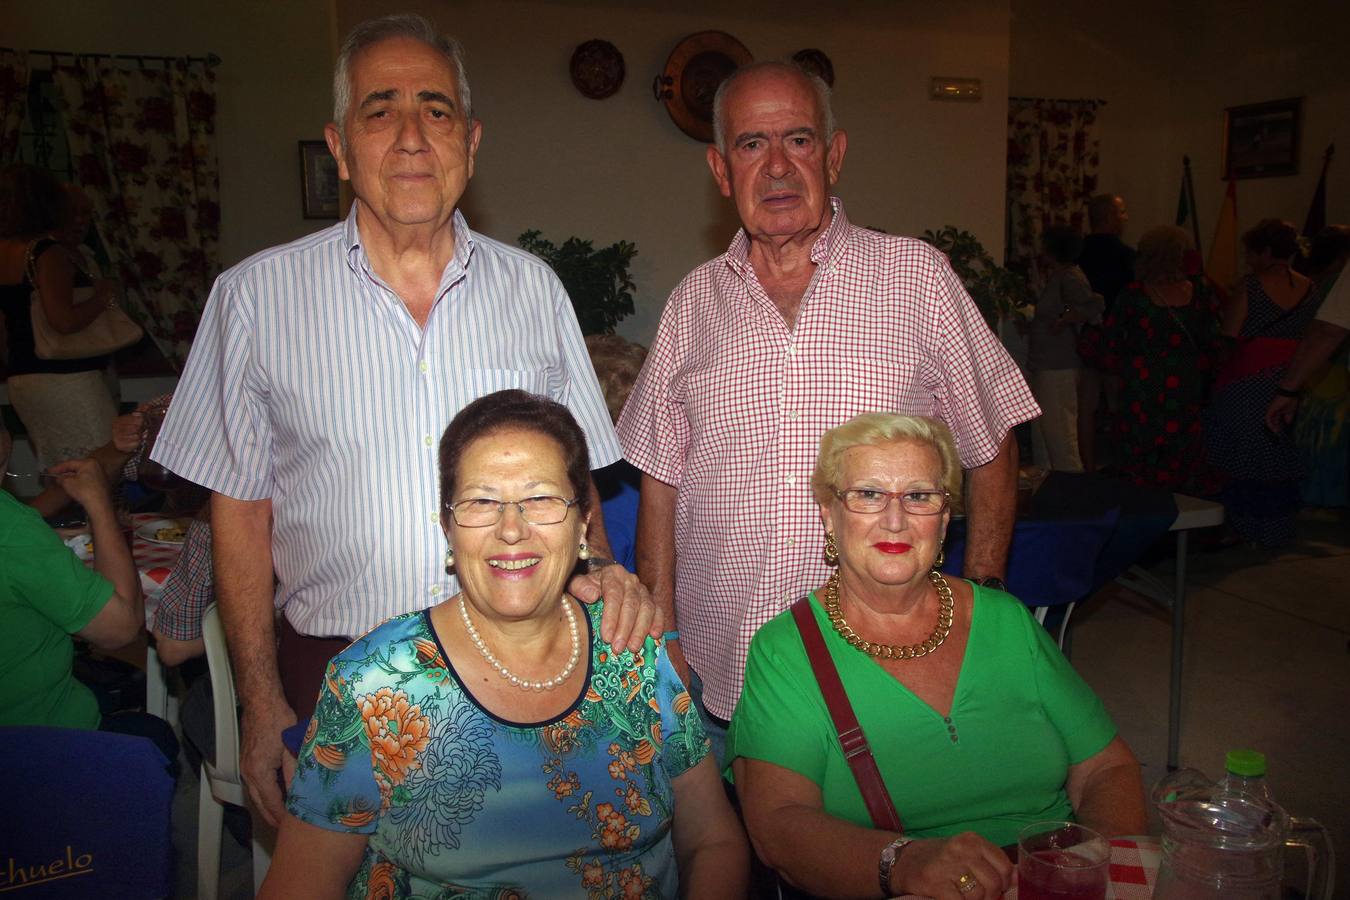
left=728, top=413, right=1145, bottom=900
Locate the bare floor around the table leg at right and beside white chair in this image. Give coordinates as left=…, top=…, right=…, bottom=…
left=174, top=511, right=1350, bottom=899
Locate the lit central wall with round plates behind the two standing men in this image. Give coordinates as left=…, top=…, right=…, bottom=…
left=338, top=0, right=1008, bottom=341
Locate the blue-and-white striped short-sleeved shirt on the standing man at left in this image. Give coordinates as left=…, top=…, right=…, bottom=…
left=153, top=208, right=620, bottom=637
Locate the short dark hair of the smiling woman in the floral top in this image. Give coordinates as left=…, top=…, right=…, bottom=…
left=440, top=390, right=591, bottom=517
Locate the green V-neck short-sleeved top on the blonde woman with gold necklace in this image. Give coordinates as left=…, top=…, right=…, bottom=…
left=728, top=586, right=1115, bottom=846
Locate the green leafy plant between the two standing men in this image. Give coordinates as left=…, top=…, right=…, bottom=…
left=516, top=231, right=637, bottom=335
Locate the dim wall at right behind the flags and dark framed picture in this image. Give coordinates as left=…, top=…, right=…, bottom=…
left=1008, top=0, right=1350, bottom=252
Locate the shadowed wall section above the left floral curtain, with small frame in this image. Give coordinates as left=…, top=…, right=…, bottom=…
left=9, top=0, right=333, bottom=266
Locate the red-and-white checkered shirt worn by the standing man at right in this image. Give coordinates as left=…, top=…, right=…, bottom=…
left=618, top=198, right=1041, bottom=718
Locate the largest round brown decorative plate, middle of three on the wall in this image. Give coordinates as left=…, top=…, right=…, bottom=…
left=652, top=31, right=755, bottom=143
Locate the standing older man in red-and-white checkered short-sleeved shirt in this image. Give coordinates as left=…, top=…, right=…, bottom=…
left=618, top=63, right=1040, bottom=744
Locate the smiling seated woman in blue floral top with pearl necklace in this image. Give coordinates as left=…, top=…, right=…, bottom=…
left=262, top=391, right=747, bottom=899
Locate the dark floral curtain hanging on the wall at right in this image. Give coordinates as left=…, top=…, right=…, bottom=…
left=1007, top=99, right=1100, bottom=282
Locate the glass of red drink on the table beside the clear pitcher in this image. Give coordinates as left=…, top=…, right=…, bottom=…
left=1017, top=822, right=1111, bottom=900
